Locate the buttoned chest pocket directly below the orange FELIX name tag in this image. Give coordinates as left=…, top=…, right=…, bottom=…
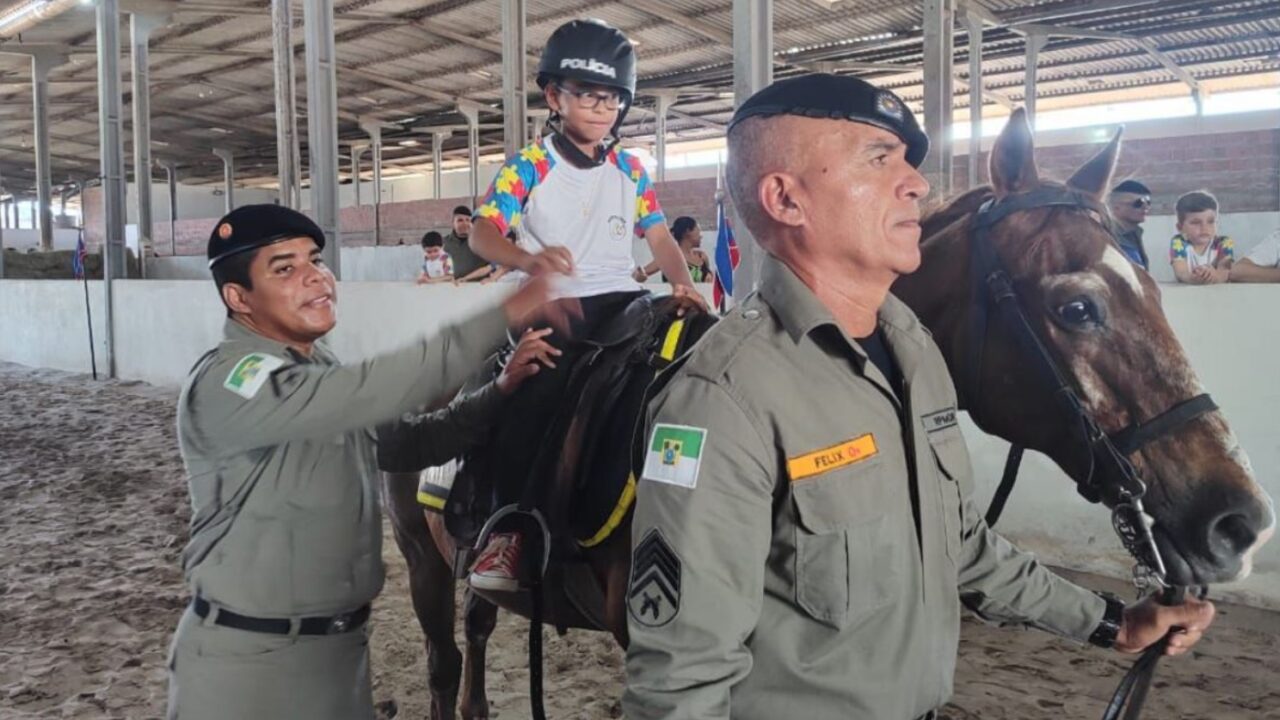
left=791, top=457, right=899, bottom=628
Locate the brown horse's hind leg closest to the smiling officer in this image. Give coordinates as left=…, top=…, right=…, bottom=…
left=383, top=473, right=462, bottom=720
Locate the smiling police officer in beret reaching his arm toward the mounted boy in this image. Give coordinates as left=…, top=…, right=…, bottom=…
left=169, top=205, right=563, bottom=720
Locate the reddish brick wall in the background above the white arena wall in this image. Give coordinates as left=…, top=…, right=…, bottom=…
left=84, top=129, right=1280, bottom=255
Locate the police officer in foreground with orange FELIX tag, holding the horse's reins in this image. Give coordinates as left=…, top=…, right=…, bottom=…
left=622, top=74, right=1212, bottom=720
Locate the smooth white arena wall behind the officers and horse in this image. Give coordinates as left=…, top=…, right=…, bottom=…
left=0, top=279, right=1280, bottom=609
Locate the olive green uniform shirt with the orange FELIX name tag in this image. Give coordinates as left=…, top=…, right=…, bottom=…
left=622, top=258, right=1105, bottom=720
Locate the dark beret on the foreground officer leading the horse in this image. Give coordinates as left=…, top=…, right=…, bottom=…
left=728, top=73, right=929, bottom=168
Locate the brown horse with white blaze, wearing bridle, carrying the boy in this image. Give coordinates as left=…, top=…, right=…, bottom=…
left=385, top=107, right=1274, bottom=720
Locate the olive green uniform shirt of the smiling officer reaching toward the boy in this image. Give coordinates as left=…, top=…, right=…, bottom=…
left=178, top=307, right=506, bottom=618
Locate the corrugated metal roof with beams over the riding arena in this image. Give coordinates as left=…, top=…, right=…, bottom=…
left=0, top=0, right=1280, bottom=192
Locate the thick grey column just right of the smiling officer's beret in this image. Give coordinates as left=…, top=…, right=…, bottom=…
left=302, top=0, right=342, bottom=278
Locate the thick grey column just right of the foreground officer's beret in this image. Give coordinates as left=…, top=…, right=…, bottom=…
left=920, top=0, right=954, bottom=196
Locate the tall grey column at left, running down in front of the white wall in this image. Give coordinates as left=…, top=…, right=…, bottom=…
left=97, top=0, right=125, bottom=378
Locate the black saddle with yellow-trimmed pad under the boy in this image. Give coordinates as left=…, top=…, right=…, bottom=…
left=444, top=296, right=716, bottom=629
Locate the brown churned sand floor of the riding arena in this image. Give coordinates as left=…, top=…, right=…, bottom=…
left=0, top=364, right=1280, bottom=720
